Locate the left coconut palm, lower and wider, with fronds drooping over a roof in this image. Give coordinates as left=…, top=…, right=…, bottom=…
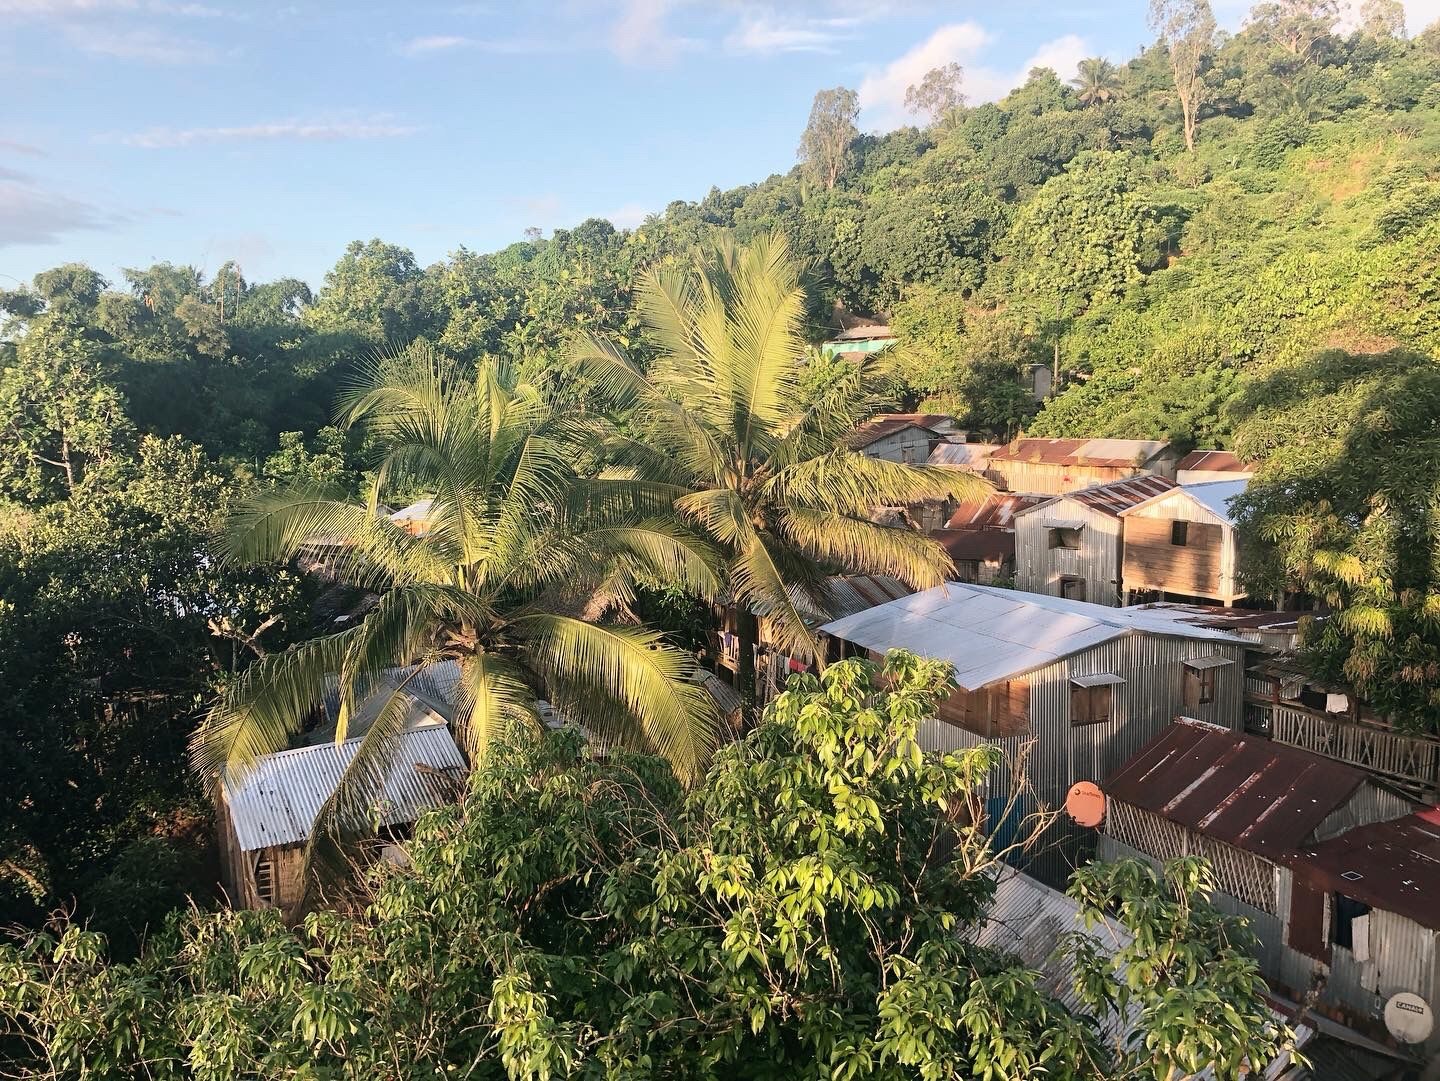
left=193, top=347, right=719, bottom=869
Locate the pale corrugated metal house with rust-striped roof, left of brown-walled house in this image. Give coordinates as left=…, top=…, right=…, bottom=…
left=1015, top=475, right=1175, bottom=605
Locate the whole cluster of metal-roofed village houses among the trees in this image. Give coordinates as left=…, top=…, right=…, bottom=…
left=220, top=325, right=1440, bottom=1078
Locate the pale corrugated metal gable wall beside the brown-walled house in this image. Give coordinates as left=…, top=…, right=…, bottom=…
left=1015, top=499, right=1120, bottom=607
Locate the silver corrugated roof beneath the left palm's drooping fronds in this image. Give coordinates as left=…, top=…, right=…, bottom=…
left=222, top=725, right=465, bottom=852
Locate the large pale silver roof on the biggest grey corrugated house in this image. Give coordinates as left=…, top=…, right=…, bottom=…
left=821, top=582, right=1244, bottom=691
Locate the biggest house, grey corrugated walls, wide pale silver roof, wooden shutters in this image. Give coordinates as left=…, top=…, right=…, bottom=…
left=821, top=583, right=1246, bottom=884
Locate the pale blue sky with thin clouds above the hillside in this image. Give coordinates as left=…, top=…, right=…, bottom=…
left=8, top=0, right=1440, bottom=288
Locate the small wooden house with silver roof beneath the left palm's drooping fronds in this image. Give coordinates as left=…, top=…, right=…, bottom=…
left=216, top=724, right=465, bottom=920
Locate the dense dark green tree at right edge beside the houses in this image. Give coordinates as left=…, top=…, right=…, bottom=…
left=1234, top=350, right=1440, bottom=731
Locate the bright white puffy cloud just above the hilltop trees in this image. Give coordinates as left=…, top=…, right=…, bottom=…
left=860, top=22, right=1093, bottom=131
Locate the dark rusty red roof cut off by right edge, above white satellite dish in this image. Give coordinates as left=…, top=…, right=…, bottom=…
left=1292, top=809, right=1440, bottom=930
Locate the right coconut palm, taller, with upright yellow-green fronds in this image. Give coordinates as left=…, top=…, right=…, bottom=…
left=572, top=235, right=988, bottom=705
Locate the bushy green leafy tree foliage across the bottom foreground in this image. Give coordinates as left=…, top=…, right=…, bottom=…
left=0, top=652, right=1307, bottom=1081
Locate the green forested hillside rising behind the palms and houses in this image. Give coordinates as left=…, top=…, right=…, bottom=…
left=0, top=0, right=1440, bottom=937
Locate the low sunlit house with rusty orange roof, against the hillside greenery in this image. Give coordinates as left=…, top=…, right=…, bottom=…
left=989, top=439, right=1179, bottom=495
